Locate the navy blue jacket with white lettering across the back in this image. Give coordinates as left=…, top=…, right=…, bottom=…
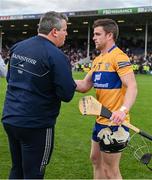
left=2, top=36, right=76, bottom=128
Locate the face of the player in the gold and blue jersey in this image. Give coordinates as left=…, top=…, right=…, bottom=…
left=93, top=26, right=108, bottom=50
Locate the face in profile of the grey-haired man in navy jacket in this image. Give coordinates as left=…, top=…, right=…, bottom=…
left=57, top=20, right=67, bottom=47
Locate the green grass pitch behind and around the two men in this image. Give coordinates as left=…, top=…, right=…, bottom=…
left=0, top=73, right=152, bottom=179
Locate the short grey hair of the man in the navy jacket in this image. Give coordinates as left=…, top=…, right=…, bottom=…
left=38, top=11, right=68, bottom=35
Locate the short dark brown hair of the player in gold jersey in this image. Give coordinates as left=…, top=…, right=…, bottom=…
left=93, top=18, right=119, bottom=41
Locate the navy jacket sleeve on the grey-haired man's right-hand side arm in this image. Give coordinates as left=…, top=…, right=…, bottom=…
left=53, top=53, right=76, bottom=102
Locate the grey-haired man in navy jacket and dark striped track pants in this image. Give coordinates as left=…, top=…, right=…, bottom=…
left=2, top=12, right=76, bottom=179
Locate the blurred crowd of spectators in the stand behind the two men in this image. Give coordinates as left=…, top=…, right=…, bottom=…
left=1, top=40, right=152, bottom=74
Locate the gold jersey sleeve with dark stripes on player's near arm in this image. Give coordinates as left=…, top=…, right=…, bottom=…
left=114, top=53, right=133, bottom=76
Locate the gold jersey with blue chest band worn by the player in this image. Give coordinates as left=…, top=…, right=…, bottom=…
left=89, top=45, right=133, bottom=125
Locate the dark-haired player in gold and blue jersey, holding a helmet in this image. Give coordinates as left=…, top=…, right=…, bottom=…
left=75, top=19, right=137, bottom=179
